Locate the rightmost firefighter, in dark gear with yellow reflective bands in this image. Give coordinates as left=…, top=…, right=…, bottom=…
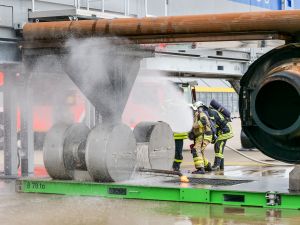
left=208, top=107, right=233, bottom=171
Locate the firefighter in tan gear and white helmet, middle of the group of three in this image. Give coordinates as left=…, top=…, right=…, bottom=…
left=191, top=101, right=212, bottom=174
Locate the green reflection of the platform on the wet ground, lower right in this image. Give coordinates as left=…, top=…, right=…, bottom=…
left=157, top=200, right=300, bottom=225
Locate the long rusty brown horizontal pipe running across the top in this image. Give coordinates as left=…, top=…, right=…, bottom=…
left=23, top=10, right=300, bottom=42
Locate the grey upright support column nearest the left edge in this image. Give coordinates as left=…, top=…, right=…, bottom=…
left=3, top=64, right=18, bottom=178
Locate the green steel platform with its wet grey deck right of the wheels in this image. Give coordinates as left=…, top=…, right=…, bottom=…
left=16, top=174, right=300, bottom=209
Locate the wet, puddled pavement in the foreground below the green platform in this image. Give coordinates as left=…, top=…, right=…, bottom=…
left=0, top=180, right=300, bottom=225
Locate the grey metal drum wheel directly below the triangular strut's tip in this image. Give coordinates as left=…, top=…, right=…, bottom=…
left=85, top=124, right=137, bottom=182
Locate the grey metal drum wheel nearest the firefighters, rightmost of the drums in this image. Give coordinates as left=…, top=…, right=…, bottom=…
left=133, top=122, right=175, bottom=170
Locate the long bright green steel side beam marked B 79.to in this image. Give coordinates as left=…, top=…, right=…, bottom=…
left=16, top=179, right=300, bottom=209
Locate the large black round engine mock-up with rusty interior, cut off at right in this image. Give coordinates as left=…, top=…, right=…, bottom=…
left=239, top=44, right=300, bottom=163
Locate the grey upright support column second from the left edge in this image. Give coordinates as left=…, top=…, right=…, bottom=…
left=19, top=71, right=34, bottom=177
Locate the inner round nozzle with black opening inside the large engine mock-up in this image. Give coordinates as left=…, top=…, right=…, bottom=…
left=254, top=69, right=300, bottom=138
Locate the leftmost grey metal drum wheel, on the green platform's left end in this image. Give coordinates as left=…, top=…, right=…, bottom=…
left=43, top=123, right=89, bottom=180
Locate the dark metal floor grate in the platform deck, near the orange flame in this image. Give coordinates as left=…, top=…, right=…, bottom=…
left=165, top=177, right=252, bottom=186
